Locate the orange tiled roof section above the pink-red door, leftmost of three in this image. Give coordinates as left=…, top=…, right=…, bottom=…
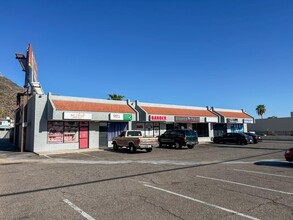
left=52, top=100, right=135, bottom=114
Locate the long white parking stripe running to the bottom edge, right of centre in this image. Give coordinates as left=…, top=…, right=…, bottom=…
left=144, top=184, right=259, bottom=220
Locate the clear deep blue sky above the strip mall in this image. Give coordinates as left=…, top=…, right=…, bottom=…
left=0, top=0, right=293, bottom=118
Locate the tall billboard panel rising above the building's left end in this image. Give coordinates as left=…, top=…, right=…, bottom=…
left=26, top=44, right=39, bottom=83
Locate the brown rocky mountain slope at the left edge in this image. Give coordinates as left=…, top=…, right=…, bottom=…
left=0, top=74, right=23, bottom=119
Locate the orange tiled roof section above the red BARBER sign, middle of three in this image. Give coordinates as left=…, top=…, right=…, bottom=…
left=141, top=106, right=217, bottom=117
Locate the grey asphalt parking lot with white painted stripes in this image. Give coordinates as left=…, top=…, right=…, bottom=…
left=0, top=141, right=293, bottom=219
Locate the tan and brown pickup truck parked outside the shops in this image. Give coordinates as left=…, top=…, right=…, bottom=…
left=112, top=130, right=158, bottom=153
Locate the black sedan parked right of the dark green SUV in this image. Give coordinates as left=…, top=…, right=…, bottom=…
left=213, top=133, right=253, bottom=144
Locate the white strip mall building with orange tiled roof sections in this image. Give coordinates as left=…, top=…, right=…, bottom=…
left=15, top=93, right=254, bottom=153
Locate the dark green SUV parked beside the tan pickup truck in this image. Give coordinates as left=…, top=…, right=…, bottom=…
left=158, top=129, right=198, bottom=149
